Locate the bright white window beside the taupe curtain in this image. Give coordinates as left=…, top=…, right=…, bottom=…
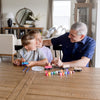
left=53, top=0, right=71, bottom=30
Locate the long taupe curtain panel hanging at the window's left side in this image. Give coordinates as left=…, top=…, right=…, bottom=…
left=47, top=0, right=53, bottom=29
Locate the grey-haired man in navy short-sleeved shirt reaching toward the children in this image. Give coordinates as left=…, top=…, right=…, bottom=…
left=44, top=22, right=95, bottom=67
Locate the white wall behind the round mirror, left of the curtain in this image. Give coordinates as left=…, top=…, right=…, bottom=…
left=2, top=0, right=48, bottom=29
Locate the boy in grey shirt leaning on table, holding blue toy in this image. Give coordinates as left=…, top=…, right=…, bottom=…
left=13, top=34, right=48, bottom=67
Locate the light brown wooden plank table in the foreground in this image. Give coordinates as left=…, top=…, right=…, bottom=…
left=0, top=63, right=100, bottom=100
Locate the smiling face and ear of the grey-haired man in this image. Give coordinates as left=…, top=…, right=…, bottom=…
left=68, top=30, right=84, bottom=43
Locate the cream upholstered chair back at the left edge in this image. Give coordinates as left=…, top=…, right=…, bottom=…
left=0, top=34, right=17, bottom=54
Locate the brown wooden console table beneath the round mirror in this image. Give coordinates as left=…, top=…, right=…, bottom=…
left=3, top=27, right=43, bottom=39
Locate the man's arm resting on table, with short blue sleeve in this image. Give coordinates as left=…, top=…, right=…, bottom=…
left=63, top=39, right=96, bottom=67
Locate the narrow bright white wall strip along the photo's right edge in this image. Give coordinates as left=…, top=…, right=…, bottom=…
left=95, top=0, right=100, bottom=68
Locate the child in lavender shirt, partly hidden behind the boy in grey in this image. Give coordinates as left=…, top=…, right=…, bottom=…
left=29, top=31, right=53, bottom=63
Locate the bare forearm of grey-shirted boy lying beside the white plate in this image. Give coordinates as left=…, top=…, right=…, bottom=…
left=26, top=59, right=48, bottom=67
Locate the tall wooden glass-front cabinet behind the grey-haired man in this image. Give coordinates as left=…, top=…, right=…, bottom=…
left=74, top=3, right=92, bottom=36
